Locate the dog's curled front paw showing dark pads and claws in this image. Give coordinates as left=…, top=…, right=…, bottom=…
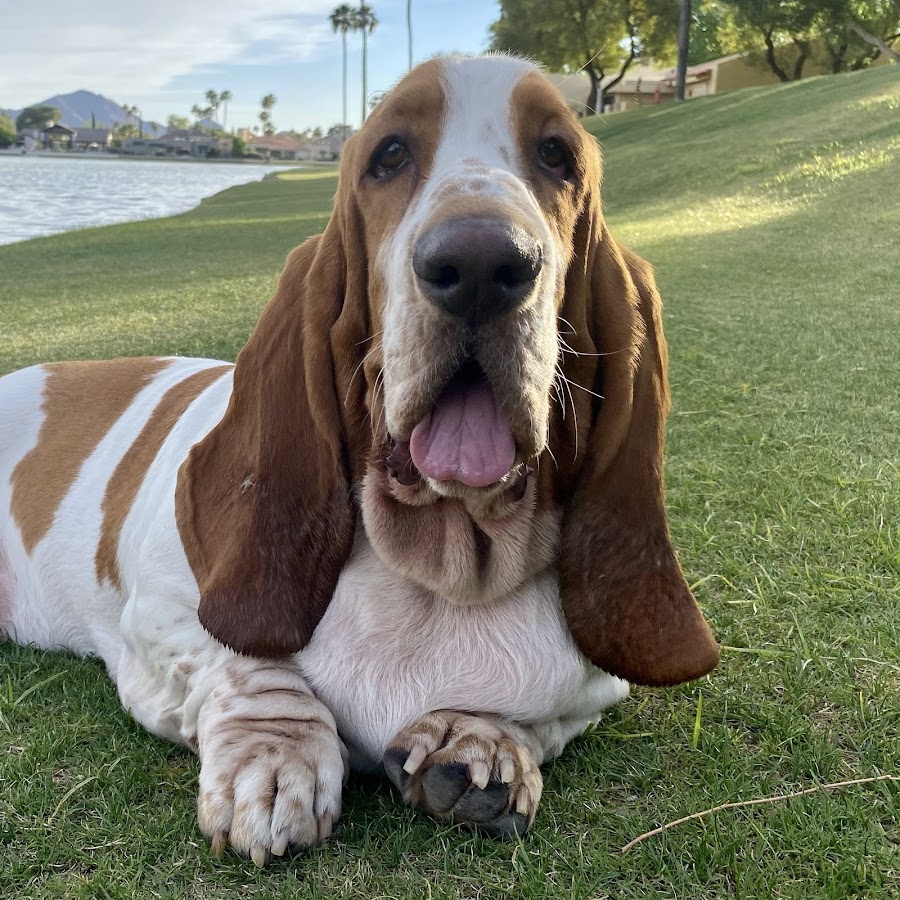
left=382, top=711, right=543, bottom=838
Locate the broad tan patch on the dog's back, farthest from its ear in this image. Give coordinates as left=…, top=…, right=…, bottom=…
left=10, top=357, right=169, bottom=554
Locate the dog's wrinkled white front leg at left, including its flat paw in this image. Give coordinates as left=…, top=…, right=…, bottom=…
left=115, top=595, right=347, bottom=865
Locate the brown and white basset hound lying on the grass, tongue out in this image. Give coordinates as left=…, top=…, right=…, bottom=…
left=0, top=56, right=718, bottom=865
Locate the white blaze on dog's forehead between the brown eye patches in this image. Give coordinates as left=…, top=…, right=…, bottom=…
left=431, top=56, right=540, bottom=182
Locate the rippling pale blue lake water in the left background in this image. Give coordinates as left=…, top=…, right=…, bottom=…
left=0, top=154, right=284, bottom=244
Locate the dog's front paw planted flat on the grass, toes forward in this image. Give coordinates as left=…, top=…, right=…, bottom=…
left=197, top=717, right=346, bottom=867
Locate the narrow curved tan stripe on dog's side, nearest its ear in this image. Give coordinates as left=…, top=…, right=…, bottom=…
left=94, top=365, right=231, bottom=589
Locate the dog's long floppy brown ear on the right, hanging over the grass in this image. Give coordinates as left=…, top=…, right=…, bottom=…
left=560, top=225, right=719, bottom=685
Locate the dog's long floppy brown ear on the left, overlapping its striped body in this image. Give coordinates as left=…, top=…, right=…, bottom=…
left=176, top=229, right=354, bottom=656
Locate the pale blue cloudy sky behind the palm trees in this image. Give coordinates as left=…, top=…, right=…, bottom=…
left=0, top=0, right=499, bottom=130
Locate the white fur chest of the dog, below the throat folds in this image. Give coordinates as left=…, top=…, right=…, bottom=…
left=298, top=539, right=604, bottom=765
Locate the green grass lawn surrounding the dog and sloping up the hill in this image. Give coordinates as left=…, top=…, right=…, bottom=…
left=0, top=66, right=900, bottom=900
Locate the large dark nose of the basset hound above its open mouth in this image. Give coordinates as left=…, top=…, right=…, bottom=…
left=413, top=216, right=543, bottom=325
